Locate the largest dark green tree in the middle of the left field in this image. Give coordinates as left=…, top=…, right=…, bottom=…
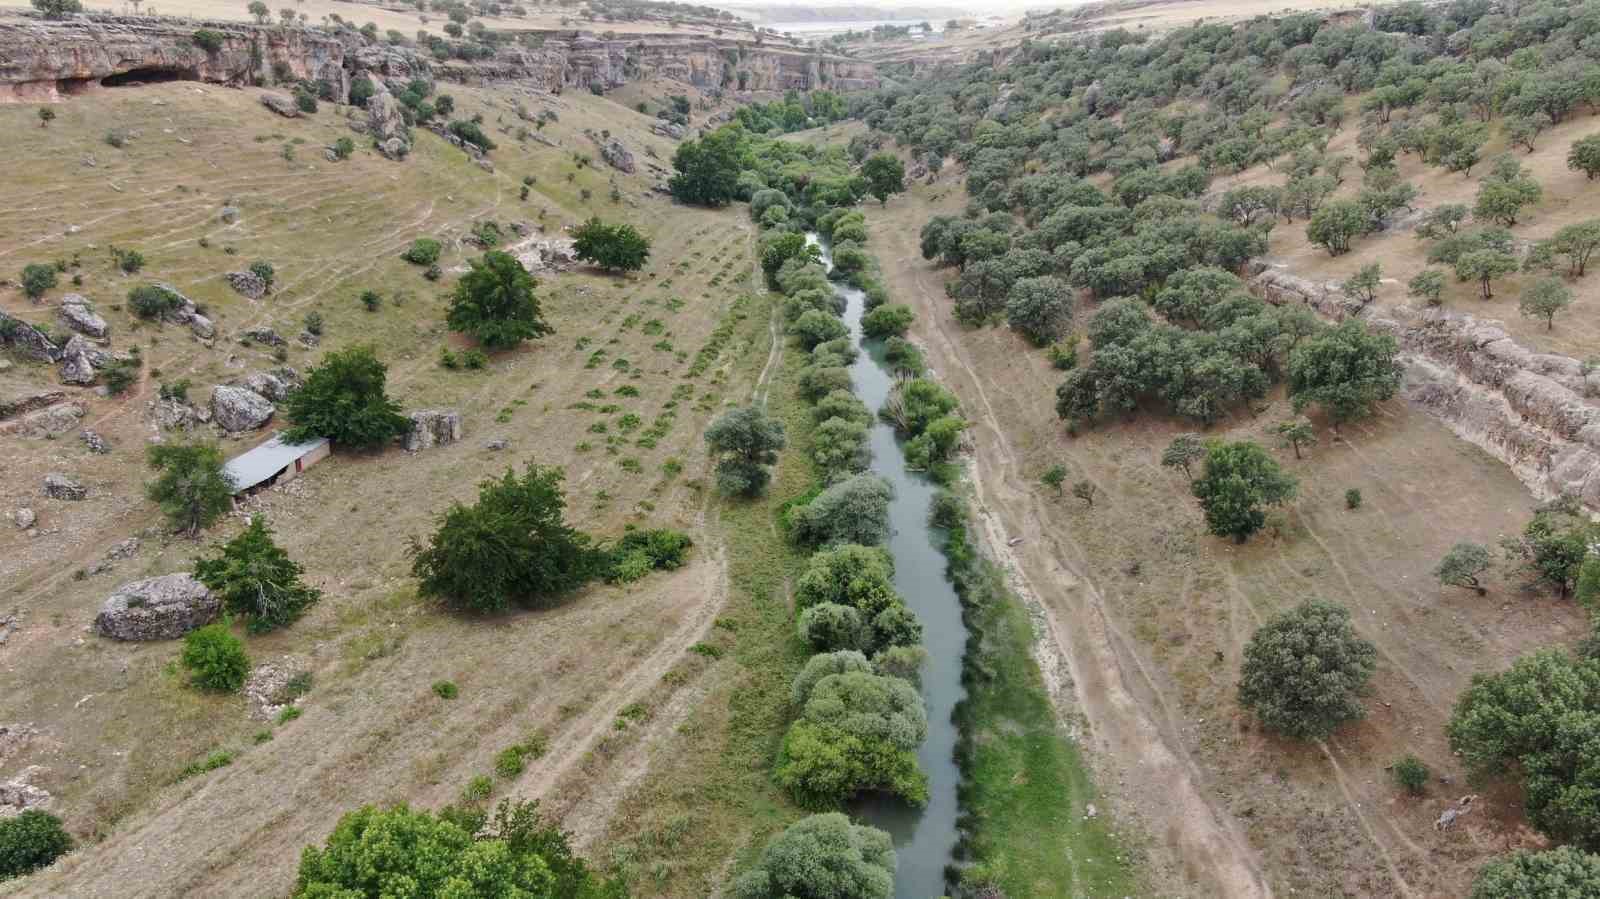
left=411, top=462, right=605, bottom=613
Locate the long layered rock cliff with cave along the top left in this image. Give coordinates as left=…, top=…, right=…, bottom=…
left=0, top=16, right=878, bottom=102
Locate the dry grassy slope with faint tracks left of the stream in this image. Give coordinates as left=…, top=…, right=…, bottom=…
left=0, top=83, right=771, bottom=896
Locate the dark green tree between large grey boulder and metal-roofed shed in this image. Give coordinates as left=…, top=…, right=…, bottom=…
left=195, top=515, right=322, bottom=633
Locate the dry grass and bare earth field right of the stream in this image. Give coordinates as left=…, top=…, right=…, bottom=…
left=870, top=178, right=1594, bottom=896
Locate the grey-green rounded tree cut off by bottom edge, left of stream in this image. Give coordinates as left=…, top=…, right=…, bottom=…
left=733, top=811, right=894, bottom=899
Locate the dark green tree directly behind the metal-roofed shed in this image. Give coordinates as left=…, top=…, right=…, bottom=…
left=283, top=344, right=411, bottom=450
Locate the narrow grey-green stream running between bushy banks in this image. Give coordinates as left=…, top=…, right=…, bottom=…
left=806, top=234, right=966, bottom=899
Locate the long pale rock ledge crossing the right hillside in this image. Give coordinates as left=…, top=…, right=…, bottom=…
left=1251, top=262, right=1600, bottom=509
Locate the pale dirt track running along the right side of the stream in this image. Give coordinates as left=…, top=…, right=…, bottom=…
left=874, top=204, right=1272, bottom=897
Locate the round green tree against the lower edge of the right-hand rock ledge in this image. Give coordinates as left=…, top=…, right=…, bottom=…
left=1288, top=318, right=1400, bottom=430
